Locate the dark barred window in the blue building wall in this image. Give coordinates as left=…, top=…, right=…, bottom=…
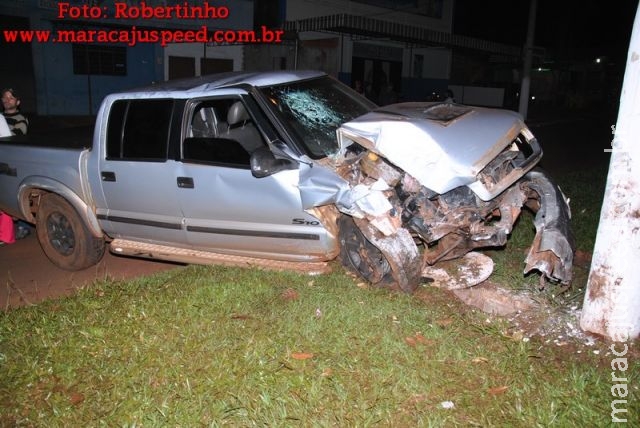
left=72, top=44, right=127, bottom=76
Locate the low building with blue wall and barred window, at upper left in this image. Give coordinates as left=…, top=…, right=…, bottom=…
left=0, top=0, right=253, bottom=115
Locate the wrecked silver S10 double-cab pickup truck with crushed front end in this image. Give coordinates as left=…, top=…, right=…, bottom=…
left=0, top=71, right=573, bottom=292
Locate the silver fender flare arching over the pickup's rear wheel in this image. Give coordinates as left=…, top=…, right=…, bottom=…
left=18, top=176, right=104, bottom=238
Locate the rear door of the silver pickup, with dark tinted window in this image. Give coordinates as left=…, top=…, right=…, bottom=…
left=97, top=99, right=186, bottom=245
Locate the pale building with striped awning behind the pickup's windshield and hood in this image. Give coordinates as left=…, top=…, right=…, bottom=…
left=245, top=0, right=522, bottom=106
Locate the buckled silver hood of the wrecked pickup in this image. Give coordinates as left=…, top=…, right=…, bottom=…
left=337, top=103, right=525, bottom=193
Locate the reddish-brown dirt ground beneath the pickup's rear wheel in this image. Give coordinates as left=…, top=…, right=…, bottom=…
left=0, top=233, right=180, bottom=310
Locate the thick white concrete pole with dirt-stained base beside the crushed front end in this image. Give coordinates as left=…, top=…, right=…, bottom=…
left=580, top=4, right=640, bottom=342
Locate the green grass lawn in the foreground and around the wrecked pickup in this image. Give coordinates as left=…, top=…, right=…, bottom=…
left=0, top=166, right=640, bottom=427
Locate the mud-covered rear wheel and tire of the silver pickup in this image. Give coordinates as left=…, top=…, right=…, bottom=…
left=36, top=193, right=105, bottom=271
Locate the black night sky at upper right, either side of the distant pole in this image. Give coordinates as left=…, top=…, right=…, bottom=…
left=454, top=0, right=638, bottom=63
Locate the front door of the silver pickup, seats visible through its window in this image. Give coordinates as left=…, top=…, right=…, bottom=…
left=178, top=96, right=324, bottom=259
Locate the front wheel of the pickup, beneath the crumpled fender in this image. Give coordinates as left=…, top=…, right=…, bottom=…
left=338, top=215, right=393, bottom=286
